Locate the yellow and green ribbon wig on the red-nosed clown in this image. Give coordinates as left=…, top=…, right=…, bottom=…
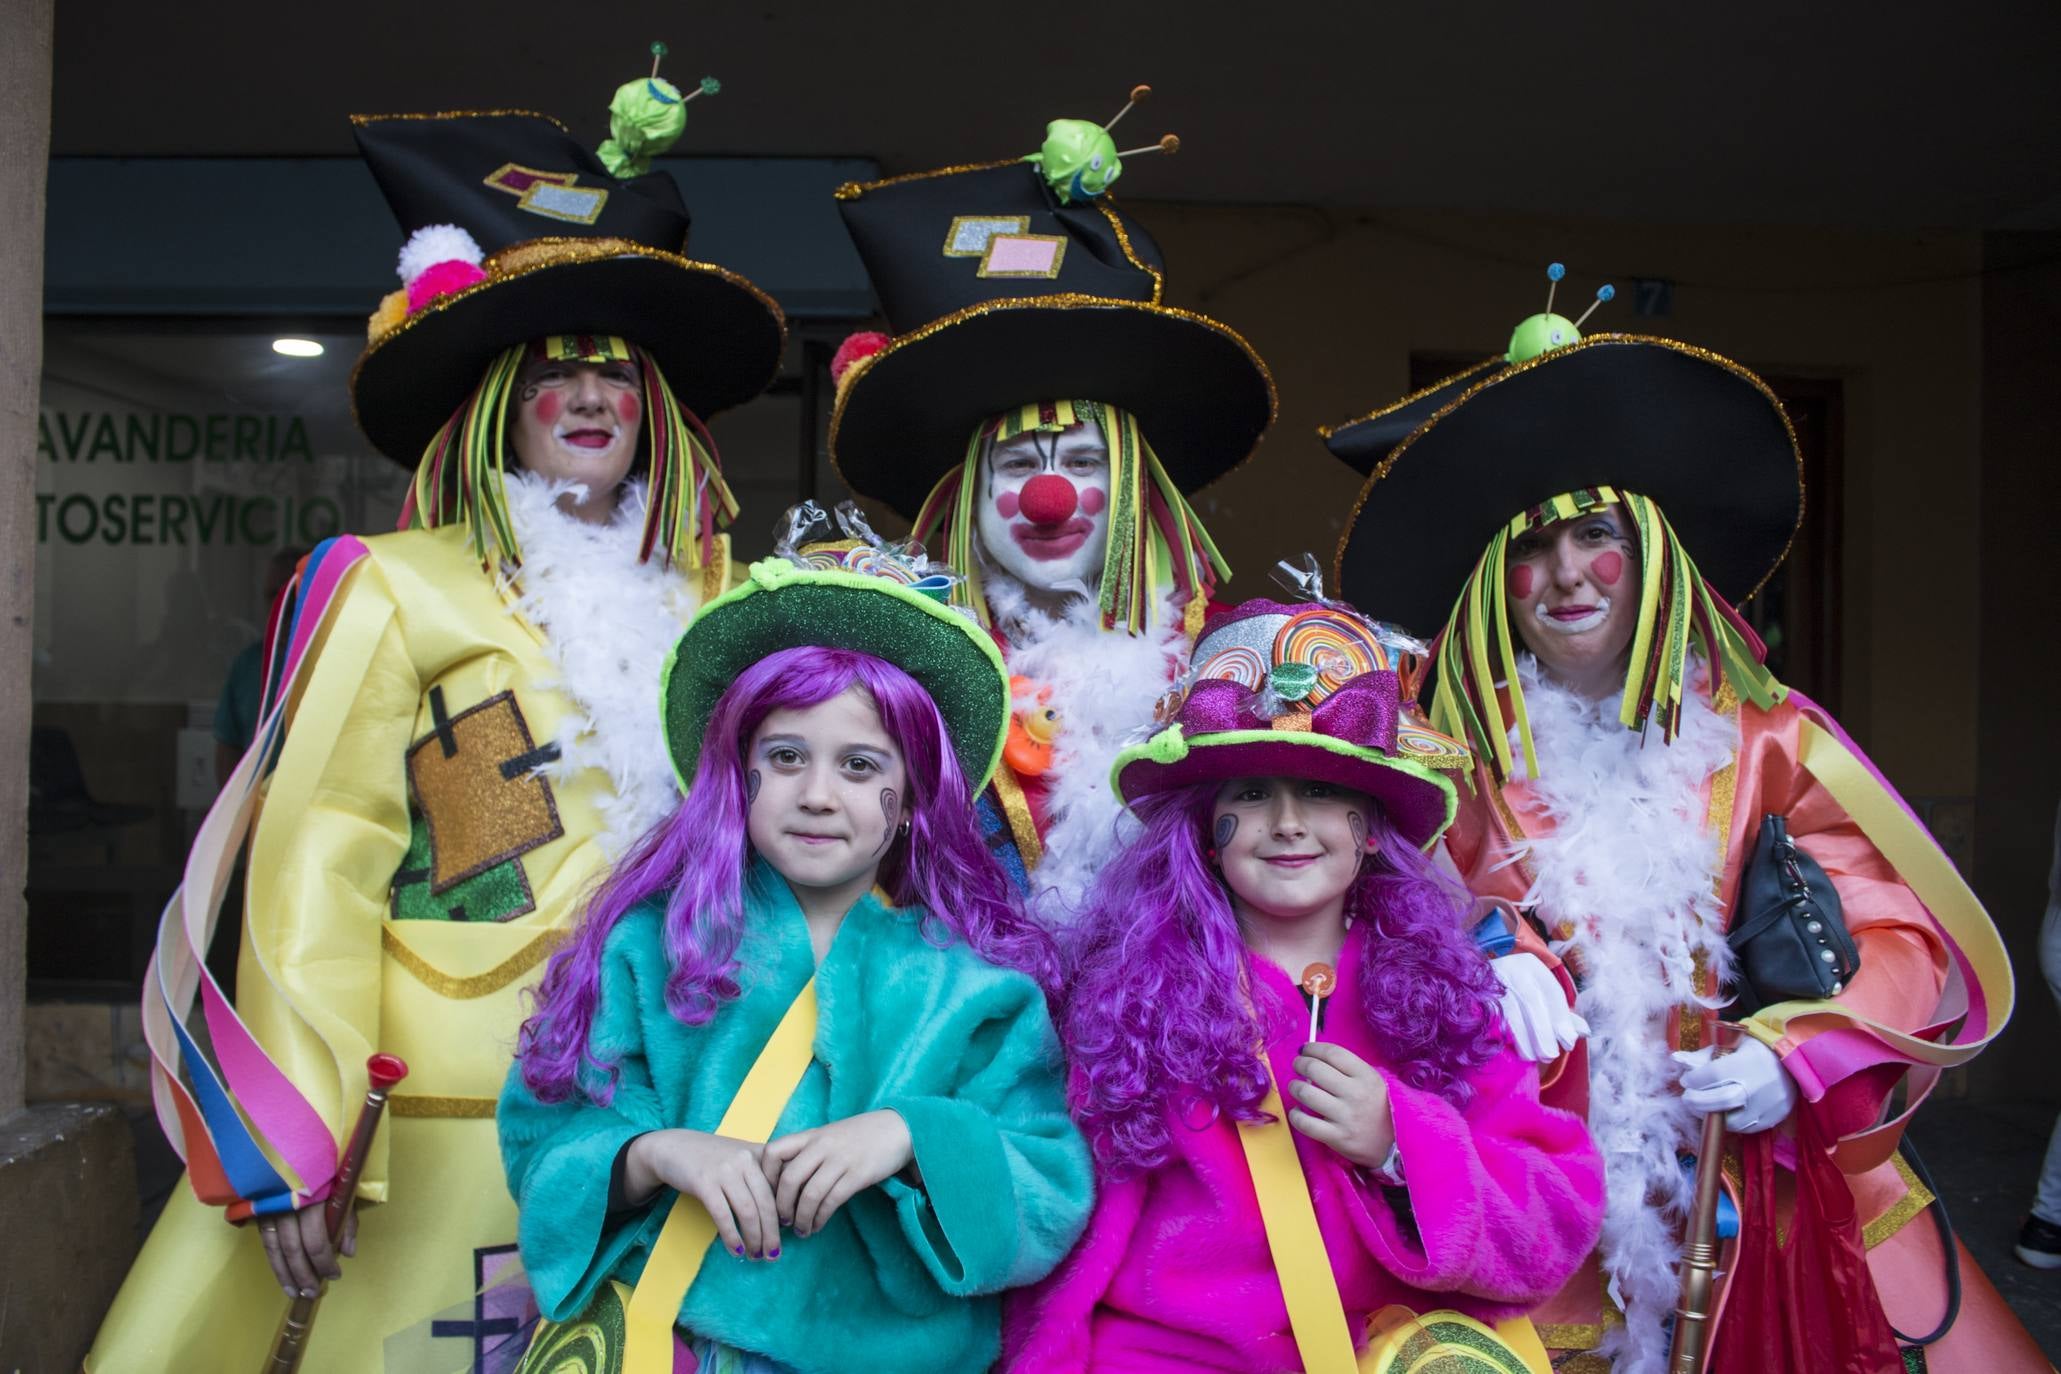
left=911, top=400, right=1230, bottom=634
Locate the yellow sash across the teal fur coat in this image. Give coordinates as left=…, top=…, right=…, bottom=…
left=622, top=978, right=816, bottom=1374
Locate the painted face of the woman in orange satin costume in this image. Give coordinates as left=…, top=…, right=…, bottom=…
left=1505, top=505, right=1641, bottom=694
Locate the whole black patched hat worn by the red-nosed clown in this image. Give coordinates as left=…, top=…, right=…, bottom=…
left=831, top=163, right=1278, bottom=515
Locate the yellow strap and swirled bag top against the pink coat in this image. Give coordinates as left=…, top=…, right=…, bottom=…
left=1239, top=1053, right=1552, bottom=1374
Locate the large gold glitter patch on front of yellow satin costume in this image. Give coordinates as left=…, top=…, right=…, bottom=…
left=408, top=688, right=565, bottom=894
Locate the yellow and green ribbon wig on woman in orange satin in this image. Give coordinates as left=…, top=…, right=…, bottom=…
left=1430, top=486, right=1787, bottom=783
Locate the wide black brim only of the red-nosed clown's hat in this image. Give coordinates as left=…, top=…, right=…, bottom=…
left=831, top=295, right=1278, bottom=517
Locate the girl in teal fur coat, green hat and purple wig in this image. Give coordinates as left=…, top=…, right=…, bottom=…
left=499, top=558, right=1092, bottom=1374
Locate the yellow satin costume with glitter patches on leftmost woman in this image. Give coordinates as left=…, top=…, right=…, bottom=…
left=87, top=525, right=728, bottom=1374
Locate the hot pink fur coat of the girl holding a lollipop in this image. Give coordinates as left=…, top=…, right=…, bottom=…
left=1004, top=929, right=1603, bottom=1374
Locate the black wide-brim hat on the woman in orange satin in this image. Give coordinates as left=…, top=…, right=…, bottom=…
left=1325, top=334, right=1803, bottom=634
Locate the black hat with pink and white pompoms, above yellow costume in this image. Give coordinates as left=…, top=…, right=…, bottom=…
left=350, top=111, right=787, bottom=468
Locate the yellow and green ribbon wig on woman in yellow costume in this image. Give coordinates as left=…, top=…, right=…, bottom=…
left=400, top=334, right=738, bottom=569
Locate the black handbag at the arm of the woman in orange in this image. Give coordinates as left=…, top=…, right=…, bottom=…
left=1725, top=812, right=1861, bottom=1018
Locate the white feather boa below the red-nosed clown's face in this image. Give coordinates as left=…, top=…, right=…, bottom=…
left=983, top=569, right=1187, bottom=927
